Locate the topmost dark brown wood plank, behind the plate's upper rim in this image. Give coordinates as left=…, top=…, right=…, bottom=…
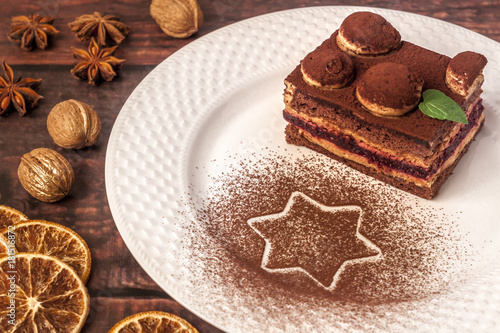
left=0, top=0, right=500, bottom=65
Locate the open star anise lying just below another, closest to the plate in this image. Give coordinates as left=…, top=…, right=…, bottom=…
left=71, top=38, right=125, bottom=85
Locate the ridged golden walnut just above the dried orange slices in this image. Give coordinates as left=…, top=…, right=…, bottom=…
left=17, top=148, right=75, bottom=202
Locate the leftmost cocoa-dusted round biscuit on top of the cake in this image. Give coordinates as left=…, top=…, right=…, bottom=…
left=300, top=50, right=354, bottom=89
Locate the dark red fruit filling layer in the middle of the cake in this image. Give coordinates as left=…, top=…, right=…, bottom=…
left=283, top=100, right=484, bottom=180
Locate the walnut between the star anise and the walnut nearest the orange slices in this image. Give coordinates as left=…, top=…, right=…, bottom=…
left=47, top=99, right=101, bottom=149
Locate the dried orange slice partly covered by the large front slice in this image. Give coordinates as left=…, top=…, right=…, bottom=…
left=0, top=220, right=91, bottom=283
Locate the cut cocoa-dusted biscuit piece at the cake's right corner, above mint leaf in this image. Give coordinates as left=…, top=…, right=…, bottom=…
left=446, top=51, right=488, bottom=97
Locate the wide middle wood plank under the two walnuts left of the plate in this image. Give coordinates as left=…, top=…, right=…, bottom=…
left=0, top=65, right=160, bottom=290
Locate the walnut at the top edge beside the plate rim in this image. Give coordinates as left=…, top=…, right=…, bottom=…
left=149, top=0, right=203, bottom=38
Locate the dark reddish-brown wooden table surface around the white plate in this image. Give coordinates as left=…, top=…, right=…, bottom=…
left=0, top=0, right=500, bottom=332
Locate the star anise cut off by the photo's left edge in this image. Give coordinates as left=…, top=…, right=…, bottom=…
left=0, top=60, right=43, bottom=116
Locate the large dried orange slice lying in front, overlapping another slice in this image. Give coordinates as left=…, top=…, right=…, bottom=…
left=0, top=253, right=90, bottom=333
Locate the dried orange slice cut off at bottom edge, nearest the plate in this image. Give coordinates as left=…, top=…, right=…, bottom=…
left=108, top=311, right=198, bottom=333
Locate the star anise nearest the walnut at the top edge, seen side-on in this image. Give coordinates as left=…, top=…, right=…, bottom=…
left=68, top=12, right=130, bottom=46
